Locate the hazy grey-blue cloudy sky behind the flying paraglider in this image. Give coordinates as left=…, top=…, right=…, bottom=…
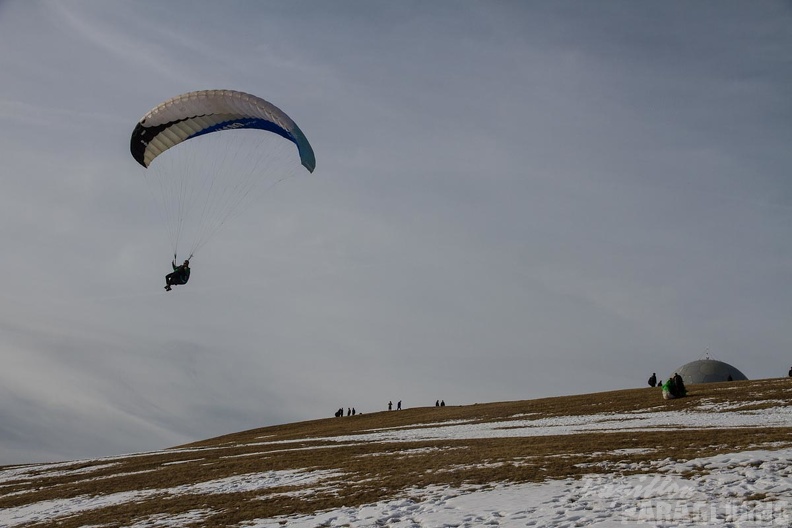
left=0, top=0, right=792, bottom=464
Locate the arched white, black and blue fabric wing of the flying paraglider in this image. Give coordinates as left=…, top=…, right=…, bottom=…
left=130, top=90, right=316, bottom=172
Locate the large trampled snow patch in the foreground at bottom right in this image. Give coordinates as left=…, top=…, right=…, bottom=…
left=255, top=449, right=792, bottom=528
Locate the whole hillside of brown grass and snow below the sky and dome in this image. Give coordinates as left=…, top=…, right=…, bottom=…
left=0, top=379, right=792, bottom=528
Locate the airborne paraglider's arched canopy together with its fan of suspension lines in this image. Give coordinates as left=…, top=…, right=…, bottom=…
left=130, top=90, right=316, bottom=258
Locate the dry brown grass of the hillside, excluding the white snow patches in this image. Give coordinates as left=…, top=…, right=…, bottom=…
left=0, top=379, right=792, bottom=528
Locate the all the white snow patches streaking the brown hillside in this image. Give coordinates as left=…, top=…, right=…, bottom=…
left=0, top=402, right=792, bottom=528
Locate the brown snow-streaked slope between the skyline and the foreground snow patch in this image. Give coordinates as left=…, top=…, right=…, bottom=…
left=0, top=379, right=792, bottom=528
